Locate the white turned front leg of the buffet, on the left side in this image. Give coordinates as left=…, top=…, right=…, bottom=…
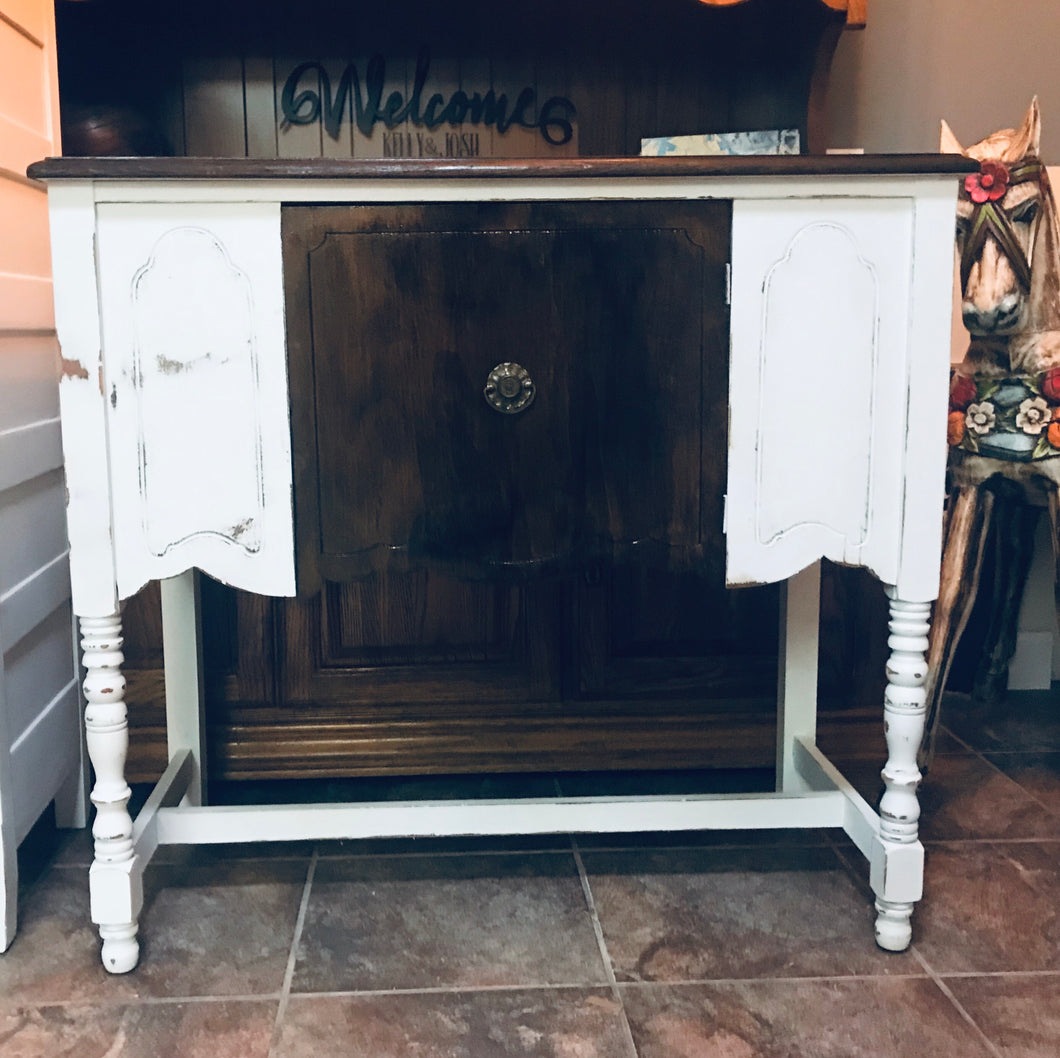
left=81, top=614, right=143, bottom=973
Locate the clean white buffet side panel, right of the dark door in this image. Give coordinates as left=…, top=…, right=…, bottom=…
left=726, top=198, right=914, bottom=584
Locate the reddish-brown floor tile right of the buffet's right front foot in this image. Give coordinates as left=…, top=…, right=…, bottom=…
left=913, top=842, right=1060, bottom=973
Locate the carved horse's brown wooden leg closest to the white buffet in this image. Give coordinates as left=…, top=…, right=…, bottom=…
left=918, top=486, right=994, bottom=769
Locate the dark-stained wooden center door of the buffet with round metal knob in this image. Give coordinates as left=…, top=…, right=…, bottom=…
left=284, top=202, right=729, bottom=585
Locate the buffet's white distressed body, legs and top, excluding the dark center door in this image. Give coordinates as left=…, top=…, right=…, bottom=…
left=31, top=156, right=965, bottom=972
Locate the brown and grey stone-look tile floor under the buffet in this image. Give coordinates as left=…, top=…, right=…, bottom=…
left=0, top=694, right=1060, bottom=1058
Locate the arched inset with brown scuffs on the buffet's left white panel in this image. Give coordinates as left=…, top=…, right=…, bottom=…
left=131, top=228, right=265, bottom=557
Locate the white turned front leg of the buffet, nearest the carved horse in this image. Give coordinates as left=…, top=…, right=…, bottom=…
left=871, top=593, right=931, bottom=951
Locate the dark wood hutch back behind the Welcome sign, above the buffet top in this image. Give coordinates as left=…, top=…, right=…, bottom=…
left=57, top=0, right=845, bottom=157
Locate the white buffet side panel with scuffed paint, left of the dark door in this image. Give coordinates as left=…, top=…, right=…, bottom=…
left=98, top=204, right=295, bottom=598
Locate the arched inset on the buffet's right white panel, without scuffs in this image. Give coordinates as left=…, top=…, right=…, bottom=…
left=755, top=224, right=879, bottom=548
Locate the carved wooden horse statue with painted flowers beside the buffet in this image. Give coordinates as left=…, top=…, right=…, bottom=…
left=921, top=99, right=1060, bottom=763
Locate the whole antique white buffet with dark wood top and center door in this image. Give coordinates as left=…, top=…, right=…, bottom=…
left=30, top=156, right=967, bottom=972
